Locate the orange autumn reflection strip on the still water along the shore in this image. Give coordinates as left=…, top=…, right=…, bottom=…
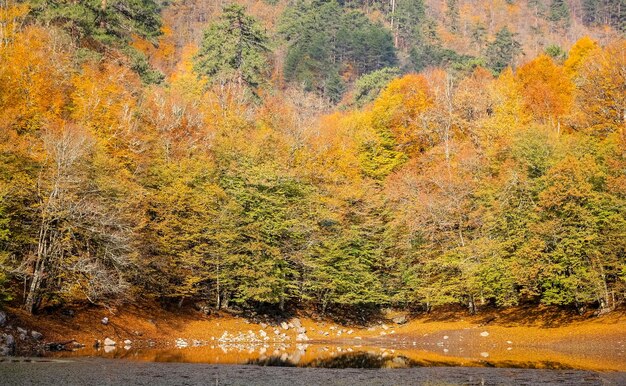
left=49, top=342, right=626, bottom=371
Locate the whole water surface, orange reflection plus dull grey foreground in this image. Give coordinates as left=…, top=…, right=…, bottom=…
left=0, top=338, right=626, bottom=386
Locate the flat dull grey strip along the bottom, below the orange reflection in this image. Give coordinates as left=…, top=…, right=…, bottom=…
left=0, top=358, right=626, bottom=386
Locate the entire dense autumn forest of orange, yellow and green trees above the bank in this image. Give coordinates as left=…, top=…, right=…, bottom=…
left=0, top=0, right=626, bottom=313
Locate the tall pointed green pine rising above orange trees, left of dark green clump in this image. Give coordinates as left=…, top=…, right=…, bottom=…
left=194, top=4, right=269, bottom=91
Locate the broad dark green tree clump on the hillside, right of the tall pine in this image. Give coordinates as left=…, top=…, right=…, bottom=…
left=280, top=0, right=397, bottom=102
